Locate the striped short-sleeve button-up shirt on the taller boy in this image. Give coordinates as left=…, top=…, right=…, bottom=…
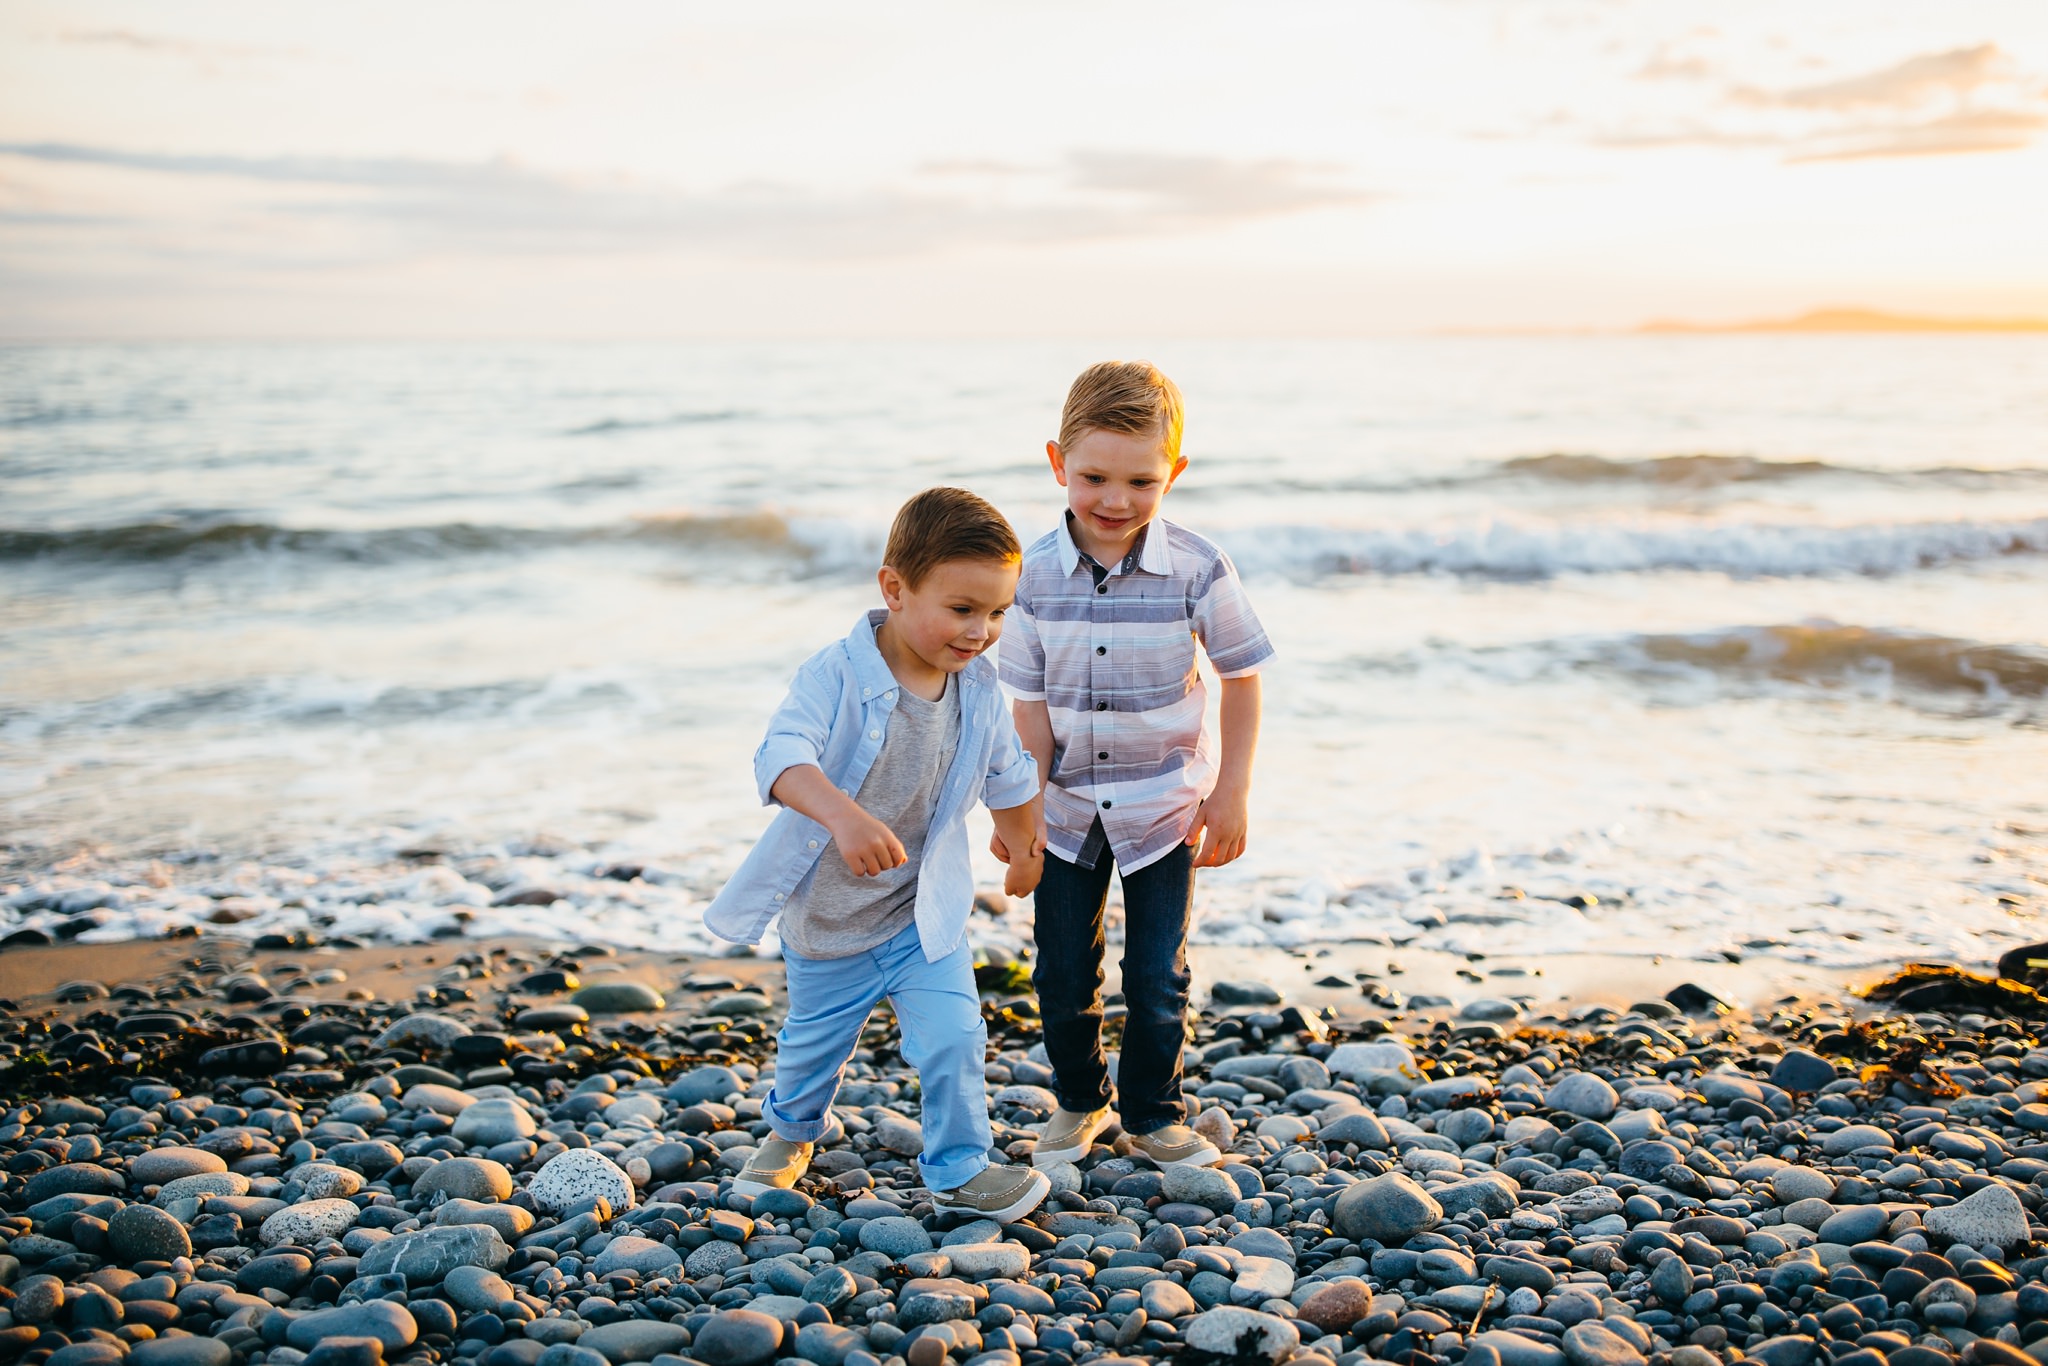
left=999, top=518, right=1274, bottom=872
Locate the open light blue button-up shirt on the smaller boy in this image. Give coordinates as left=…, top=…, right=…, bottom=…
left=705, top=608, right=1038, bottom=963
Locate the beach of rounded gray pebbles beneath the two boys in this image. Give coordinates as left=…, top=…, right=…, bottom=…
left=0, top=917, right=2048, bottom=1366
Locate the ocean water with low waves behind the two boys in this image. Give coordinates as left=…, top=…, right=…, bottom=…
left=0, top=336, right=2048, bottom=967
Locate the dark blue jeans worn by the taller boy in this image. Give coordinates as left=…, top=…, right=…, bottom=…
left=1032, top=827, right=1194, bottom=1135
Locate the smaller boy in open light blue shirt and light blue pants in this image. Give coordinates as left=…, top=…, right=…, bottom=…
left=705, top=489, right=1051, bottom=1221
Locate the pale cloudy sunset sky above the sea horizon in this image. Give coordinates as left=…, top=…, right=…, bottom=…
left=0, top=0, right=2048, bottom=338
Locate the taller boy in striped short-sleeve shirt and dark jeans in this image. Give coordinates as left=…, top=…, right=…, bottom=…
left=995, top=360, right=1272, bottom=1167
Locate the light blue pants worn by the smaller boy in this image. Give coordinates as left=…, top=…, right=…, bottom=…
left=762, top=924, right=991, bottom=1190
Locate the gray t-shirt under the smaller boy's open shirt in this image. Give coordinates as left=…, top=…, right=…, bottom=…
left=780, top=674, right=961, bottom=958
